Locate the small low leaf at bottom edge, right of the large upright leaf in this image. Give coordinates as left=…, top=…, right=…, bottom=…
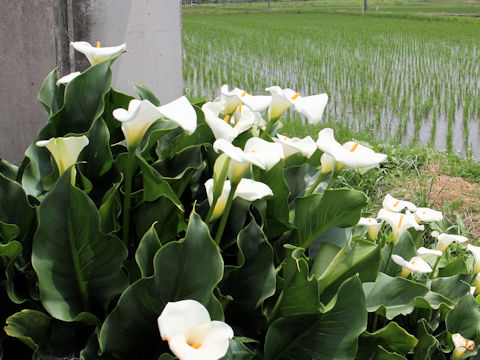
left=358, top=321, right=418, bottom=358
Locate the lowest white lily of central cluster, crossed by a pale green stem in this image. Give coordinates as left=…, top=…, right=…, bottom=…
left=205, top=179, right=273, bottom=220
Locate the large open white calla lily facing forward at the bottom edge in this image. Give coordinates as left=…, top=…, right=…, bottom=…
left=158, top=300, right=233, bottom=360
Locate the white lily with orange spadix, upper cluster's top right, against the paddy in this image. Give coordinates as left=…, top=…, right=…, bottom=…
left=265, top=86, right=328, bottom=124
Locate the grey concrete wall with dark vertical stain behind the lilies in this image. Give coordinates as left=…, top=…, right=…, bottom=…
left=0, top=0, right=183, bottom=163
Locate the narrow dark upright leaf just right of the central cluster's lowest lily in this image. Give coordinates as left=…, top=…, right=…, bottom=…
left=254, top=161, right=291, bottom=239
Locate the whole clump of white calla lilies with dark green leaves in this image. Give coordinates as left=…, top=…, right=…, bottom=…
left=0, top=41, right=480, bottom=360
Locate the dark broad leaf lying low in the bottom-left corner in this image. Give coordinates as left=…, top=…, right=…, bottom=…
left=5, top=309, right=94, bottom=359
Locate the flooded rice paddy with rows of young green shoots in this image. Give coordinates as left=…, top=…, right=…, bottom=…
left=183, top=0, right=480, bottom=159
